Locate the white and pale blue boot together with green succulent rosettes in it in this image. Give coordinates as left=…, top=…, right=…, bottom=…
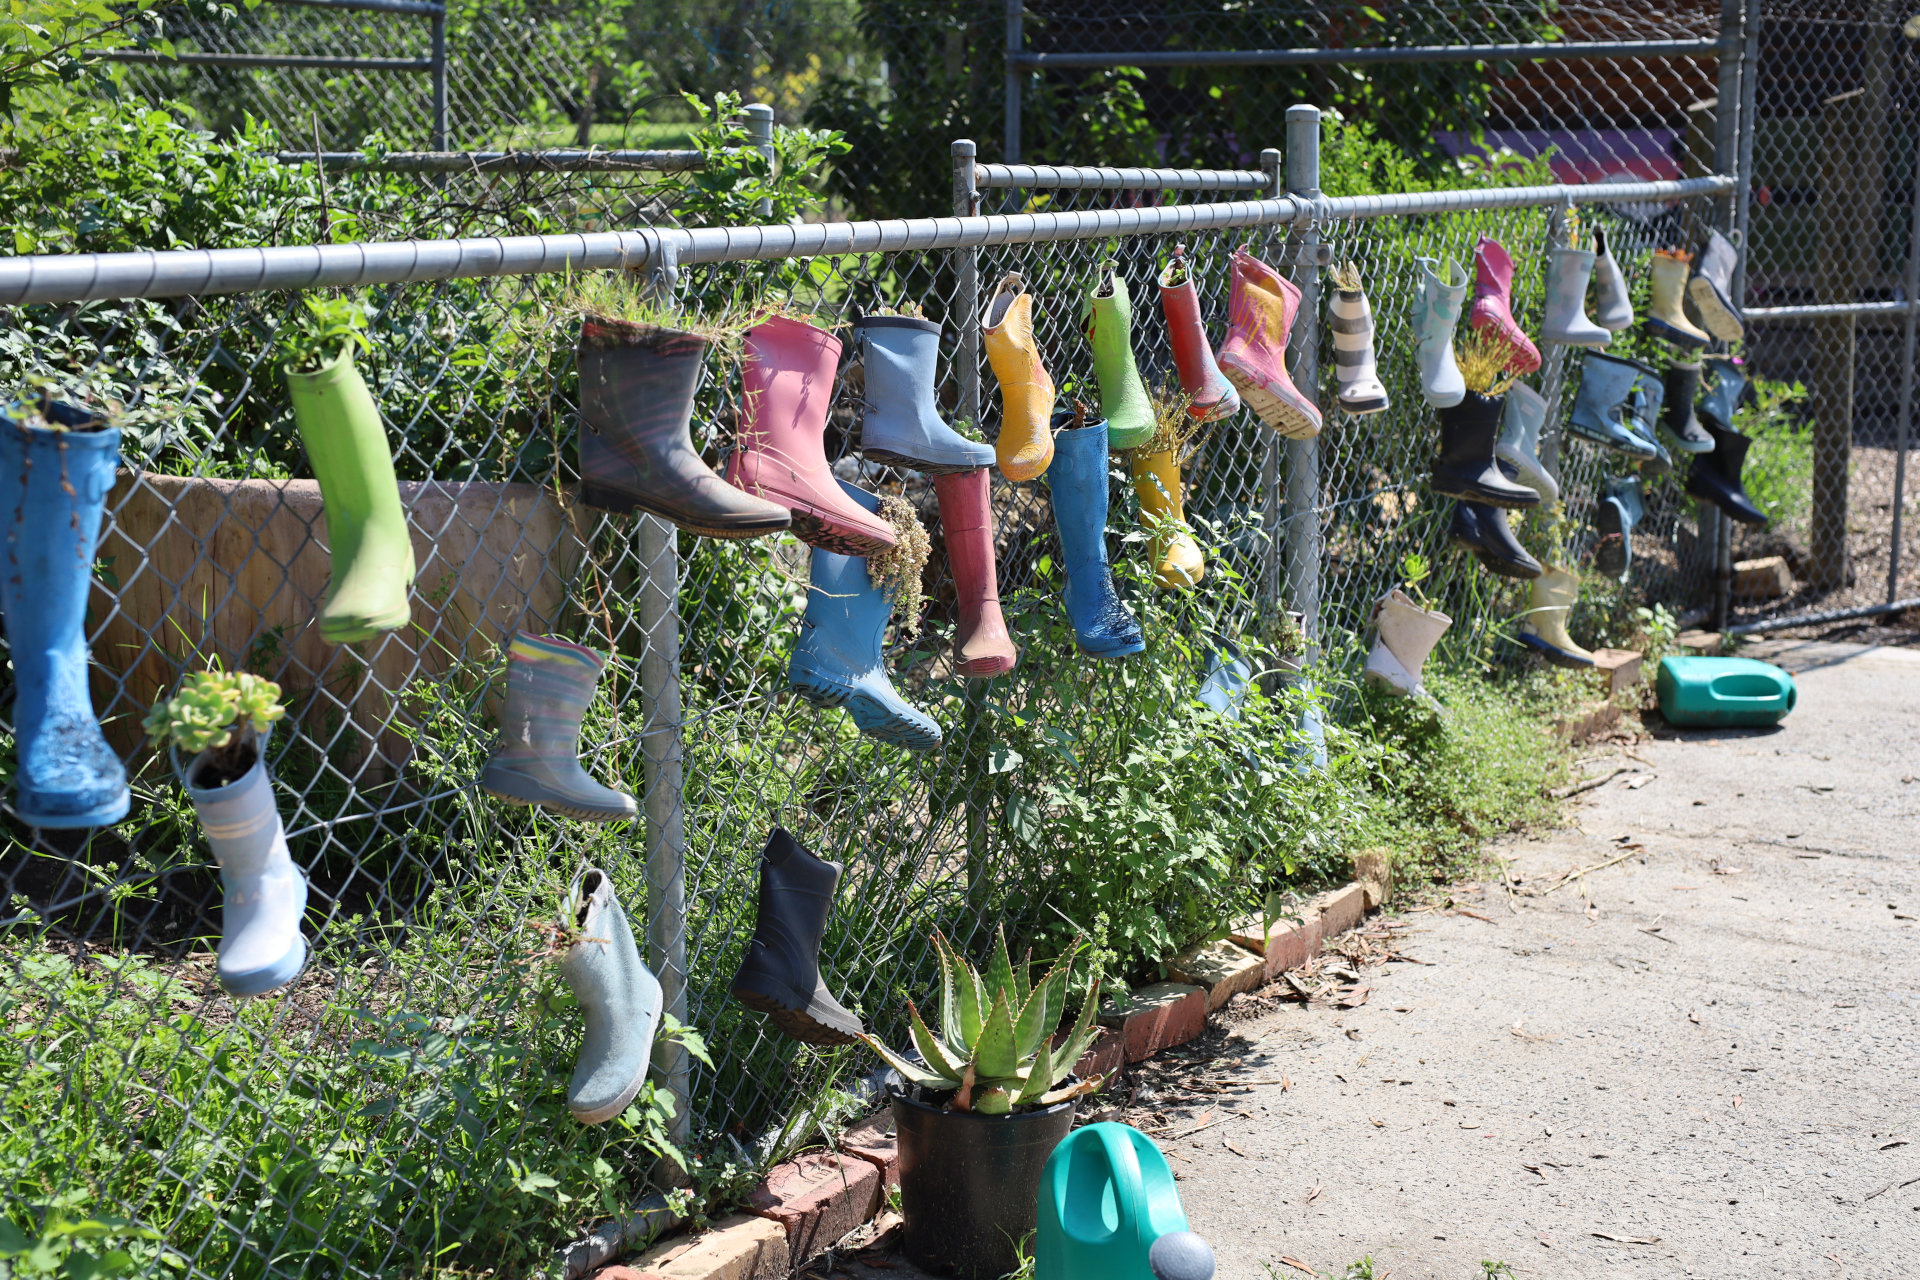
left=146, top=670, right=307, bottom=996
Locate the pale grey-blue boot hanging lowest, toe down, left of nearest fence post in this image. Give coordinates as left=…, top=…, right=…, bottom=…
left=561, top=867, right=660, bottom=1125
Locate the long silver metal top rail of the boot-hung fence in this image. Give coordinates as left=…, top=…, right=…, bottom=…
left=0, top=177, right=1734, bottom=305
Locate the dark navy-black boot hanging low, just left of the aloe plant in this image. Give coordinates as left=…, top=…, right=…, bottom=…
left=732, top=827, right=864, bottom=1044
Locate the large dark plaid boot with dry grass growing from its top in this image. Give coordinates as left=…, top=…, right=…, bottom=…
left=572, top=273, right=793, bottom=537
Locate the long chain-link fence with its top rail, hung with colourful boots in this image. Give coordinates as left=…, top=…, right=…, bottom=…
left=0, top=134, right=1743, bottom=1276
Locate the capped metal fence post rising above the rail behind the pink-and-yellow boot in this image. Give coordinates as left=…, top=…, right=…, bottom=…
left=1286, top=104, right=1321, bottom=656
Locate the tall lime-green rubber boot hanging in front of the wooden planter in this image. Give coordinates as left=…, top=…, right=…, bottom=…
left=286, top=349, right=413, bottom=645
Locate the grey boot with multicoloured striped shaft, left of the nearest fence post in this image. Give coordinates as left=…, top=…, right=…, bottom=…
left=480, top=631, right=639, bottom=821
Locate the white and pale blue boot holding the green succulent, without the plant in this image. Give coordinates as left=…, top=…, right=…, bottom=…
left=173, top=735, right=307, bottom=996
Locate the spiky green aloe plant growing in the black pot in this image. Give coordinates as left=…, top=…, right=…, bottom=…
left=862, top=931, right=1100, bottom=1115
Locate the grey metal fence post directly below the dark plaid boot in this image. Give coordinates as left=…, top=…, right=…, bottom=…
left=634, top=516, right=693, bottom=1144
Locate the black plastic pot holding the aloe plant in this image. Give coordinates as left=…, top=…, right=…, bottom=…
left=893, top=1092, right=1079, bottom=1280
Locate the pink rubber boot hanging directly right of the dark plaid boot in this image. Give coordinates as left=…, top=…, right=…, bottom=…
left=726, top=315, right=899, bottom=557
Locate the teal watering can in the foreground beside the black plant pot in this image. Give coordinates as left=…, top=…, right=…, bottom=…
left=1033, top=1125, right=1213, bottom=1280
